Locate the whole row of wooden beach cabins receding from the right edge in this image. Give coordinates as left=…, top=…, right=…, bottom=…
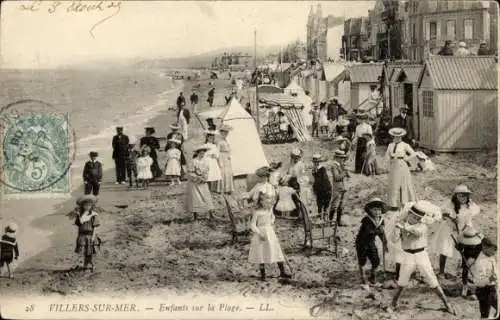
left=275, top=56, right=498, bottom=152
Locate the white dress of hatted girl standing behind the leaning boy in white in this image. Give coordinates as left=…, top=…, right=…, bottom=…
left=430, top=201, right=481, bottom=258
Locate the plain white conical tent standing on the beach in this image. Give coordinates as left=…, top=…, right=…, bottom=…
left=221, top=99, right=268, bottom=176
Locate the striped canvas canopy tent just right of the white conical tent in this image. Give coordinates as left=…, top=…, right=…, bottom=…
left=259, top=93, right=311, bottom=142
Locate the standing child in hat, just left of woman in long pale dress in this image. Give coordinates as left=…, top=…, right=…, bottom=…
left=329, top=150, right=349, bottom=227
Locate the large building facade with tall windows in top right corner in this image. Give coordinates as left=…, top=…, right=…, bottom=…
left=404, top=0, right=498, bottom=62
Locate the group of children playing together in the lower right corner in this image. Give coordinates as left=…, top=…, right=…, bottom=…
left=355, top=185, right=498, bottom=319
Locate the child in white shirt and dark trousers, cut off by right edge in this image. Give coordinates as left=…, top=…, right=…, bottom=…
left=470, top=237, right=498, bottom=319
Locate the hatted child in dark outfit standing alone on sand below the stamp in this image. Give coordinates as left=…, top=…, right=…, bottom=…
left=75, top=195, right=100, bottom=271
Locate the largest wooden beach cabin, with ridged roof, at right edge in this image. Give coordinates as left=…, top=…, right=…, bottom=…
left=416, top=56, right=498, bottom=152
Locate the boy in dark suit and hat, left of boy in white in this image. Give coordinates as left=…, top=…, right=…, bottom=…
left=356, top=198, right=387, bottom=284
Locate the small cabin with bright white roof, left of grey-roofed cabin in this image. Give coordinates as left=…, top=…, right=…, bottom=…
left=321, top=63, right=351, bottom=106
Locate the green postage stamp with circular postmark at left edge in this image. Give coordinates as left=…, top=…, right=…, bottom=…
left=0, top=99, right=75, bottom=196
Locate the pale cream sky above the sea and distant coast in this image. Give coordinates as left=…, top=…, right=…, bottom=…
left=0, top=0, right=374, bottom=69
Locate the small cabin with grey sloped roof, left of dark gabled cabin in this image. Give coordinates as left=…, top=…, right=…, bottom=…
left=345, top=63, right=383, bottom=110
